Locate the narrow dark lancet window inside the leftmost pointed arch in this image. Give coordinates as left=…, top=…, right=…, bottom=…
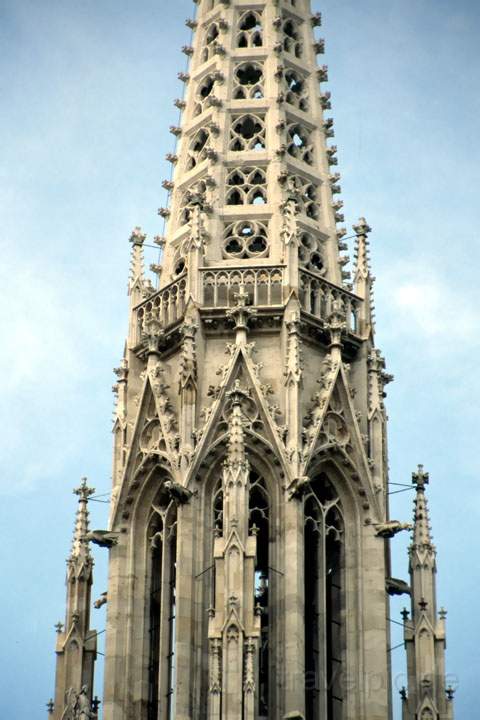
left=147, top=493, right=177, bottom=720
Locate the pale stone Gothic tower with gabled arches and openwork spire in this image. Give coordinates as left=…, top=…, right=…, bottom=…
left=48, top=0, right=452, bottom=720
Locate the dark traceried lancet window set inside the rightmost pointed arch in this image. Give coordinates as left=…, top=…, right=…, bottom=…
left=304, top=475, right=345, bottom=720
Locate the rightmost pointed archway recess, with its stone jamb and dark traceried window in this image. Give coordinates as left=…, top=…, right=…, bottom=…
left=303, top=457, right=362, bottom=720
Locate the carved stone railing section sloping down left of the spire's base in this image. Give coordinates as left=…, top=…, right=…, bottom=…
left=135, top=273, right=187, bottom=343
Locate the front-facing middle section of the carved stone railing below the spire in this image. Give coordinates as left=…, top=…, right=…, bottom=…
left=201, top=265, right=284, bottom=308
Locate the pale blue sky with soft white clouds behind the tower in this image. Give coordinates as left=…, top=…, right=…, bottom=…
left=0, top=0, right=480, bottom=720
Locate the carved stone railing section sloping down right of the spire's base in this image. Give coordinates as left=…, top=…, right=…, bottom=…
left=299, top=270, right=362, bottom=333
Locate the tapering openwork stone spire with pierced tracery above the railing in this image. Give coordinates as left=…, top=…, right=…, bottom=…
left=159, top=0, right=348, bottom=304
